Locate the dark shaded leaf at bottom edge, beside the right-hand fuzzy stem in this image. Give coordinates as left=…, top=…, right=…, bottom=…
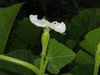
left=70, top=64, right=94, bottom=75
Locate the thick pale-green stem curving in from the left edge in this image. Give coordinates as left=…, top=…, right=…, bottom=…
left=0, top=55, right=39, bottom=75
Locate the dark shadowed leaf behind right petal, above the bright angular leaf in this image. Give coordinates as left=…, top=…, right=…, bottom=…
left=50, top=23, right=82, bottom=44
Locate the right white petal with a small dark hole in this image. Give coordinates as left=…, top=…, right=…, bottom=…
left=50, top=21, right=66, bottom=33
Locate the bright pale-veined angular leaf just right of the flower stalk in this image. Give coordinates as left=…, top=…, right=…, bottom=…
left=47, top=39, right=75, bottom=74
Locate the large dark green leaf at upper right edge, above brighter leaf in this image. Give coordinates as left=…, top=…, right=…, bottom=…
left=72, top=8, right=100, bottom=34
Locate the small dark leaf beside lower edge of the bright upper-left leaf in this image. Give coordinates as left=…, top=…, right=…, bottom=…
left=5, top=33, right=27, bottom=53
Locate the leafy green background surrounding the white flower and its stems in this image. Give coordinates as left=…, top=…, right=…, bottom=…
left=0, top=0, right=100, bottom=75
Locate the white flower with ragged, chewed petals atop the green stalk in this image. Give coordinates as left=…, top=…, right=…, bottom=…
left=29, top=15, right=66, bottom=33
